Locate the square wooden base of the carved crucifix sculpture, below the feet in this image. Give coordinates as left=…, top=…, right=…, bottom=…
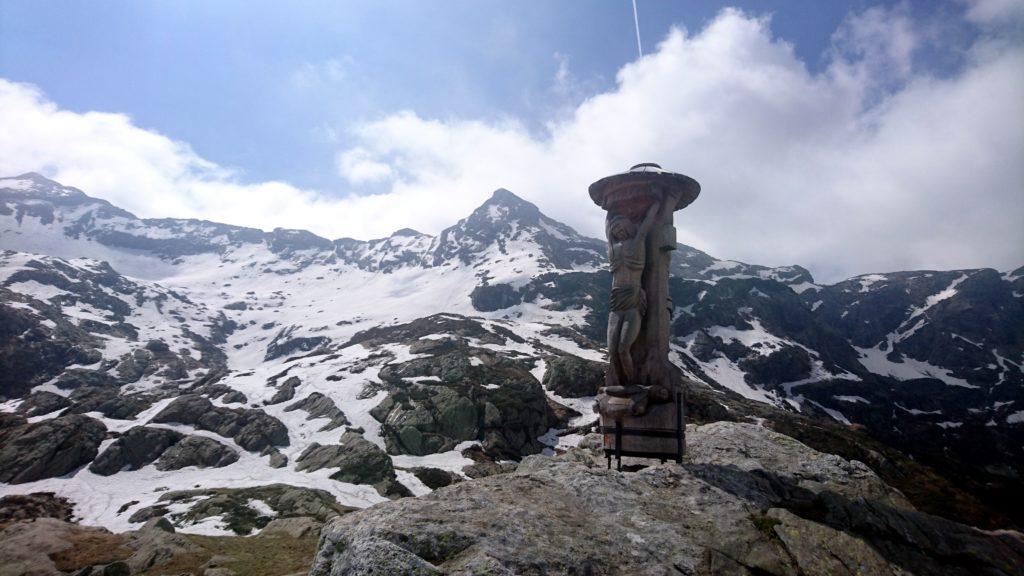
left=600, top=393, right=686, bottom=469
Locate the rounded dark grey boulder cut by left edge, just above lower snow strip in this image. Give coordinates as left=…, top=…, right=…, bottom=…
left=0, top=414, right=106, bottom=484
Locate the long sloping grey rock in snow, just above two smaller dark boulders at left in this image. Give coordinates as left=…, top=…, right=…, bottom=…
left=153, top=394, right=289, bottom=452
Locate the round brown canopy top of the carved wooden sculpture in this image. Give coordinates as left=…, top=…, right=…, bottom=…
left=590, top=162, right=700, bottom=210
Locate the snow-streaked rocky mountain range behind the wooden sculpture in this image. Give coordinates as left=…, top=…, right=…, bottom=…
left=0, top=174, right=1024, bottom=533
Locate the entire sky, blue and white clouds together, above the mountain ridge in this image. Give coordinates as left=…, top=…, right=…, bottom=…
left=0, top=0, right=1024, bottom=279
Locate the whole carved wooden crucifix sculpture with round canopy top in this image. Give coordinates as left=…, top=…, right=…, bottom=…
left=590, top=164, right=700, bottom=467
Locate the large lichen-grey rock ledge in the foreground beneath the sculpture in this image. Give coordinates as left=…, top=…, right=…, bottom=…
left=310, top=422, right=1024, bottom=576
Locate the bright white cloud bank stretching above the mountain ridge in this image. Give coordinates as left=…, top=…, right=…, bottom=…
left=0, top=1, right=1024, bottom=281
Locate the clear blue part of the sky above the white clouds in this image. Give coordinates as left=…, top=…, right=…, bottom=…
left=0, top=0, right=942, bottom=188
